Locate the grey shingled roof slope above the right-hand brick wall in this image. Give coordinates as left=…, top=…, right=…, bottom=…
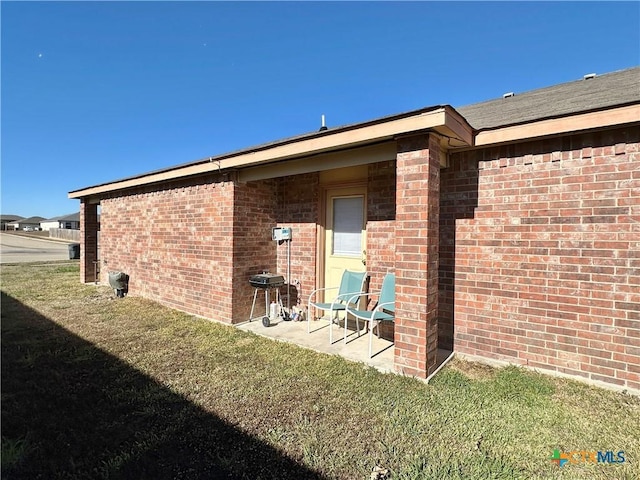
left=456, top=67, right=640, bottom=130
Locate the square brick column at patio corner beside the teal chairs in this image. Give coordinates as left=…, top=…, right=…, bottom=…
left=394, top=134, right=440, bottom=378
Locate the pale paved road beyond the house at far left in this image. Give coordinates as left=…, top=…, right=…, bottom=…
left=0, top=232, right=71, bottom=263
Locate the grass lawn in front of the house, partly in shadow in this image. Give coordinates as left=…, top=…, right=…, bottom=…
left=2, top=264, right=640, bottom=480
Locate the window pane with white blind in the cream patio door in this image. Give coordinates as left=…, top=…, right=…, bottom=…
left=333, top=197, right=364, bottom=256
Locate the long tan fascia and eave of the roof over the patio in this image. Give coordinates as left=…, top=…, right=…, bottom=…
left=68, top=105, right=474, bottom=201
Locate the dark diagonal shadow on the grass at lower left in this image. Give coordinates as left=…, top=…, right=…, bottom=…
left=2, top=293, right=324, bottom=479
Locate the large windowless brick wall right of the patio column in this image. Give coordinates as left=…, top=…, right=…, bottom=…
left=448, top=127, right=640, bottom=389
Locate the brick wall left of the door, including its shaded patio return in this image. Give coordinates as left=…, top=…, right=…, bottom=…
left=101, top=174, right=319, bottom=323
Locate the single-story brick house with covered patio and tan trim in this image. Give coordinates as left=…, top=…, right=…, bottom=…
left=69, top=68, right=640, bottom=390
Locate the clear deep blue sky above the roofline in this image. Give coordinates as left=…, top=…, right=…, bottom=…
left=0, top=1, right=640, bottom=218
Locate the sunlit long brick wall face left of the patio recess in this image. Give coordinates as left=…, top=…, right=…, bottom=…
left=101, top=176, right=239, bottom=322
